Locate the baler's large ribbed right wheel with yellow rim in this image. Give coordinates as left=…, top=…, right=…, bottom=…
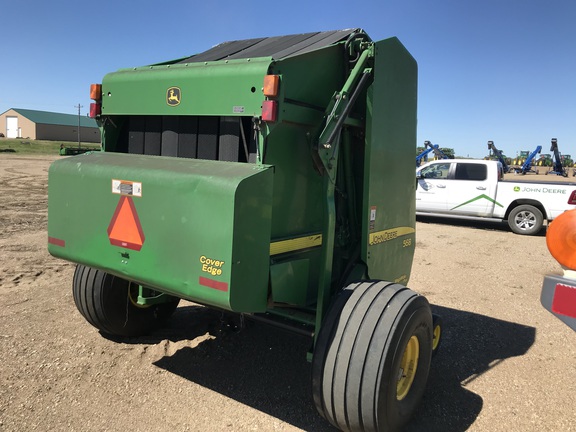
left=312, top=281, right=432, bottom=431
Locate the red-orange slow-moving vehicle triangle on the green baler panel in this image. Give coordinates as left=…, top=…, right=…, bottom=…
left=108, top=196, right=144, bottom=251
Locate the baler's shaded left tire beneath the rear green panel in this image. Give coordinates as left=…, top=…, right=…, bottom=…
left=72, top=264, right=180, bottom=336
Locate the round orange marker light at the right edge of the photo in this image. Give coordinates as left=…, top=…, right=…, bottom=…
left=546, top=210, right=576, bottom=270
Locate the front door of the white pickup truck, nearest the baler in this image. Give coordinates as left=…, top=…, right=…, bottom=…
left=416, top=161, right=452, bottom=213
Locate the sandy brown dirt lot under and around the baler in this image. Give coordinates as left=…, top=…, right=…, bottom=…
left=0, top=155, right=576, bottom=432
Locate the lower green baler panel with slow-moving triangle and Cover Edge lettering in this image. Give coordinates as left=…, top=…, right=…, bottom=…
left=48, top=153, right=273, bottom=312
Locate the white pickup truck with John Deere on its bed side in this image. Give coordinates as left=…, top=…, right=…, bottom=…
left=416, top=159, right=576, bottom=235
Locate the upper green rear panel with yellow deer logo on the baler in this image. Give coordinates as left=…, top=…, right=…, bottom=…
left=102, top=58, right=271, bottom=116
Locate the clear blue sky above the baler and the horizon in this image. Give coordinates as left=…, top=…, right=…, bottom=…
left=0, top=0, right=576, bottom=157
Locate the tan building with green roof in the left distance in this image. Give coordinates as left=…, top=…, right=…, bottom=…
left=0, top=108, right=100, bottom=143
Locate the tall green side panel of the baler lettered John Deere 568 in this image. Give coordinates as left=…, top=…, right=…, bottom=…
left=362, top=38, right=417, bottom=284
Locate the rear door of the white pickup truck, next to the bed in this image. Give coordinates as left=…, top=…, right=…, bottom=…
left=446, top=162, right=498, bottom=216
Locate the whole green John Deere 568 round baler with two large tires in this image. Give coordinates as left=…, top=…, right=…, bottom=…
left=48, top=29, right=441, bottom=431
